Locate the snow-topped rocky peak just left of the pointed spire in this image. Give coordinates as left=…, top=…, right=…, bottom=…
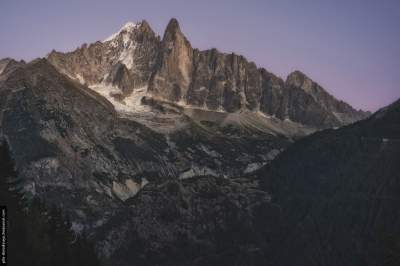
left=47, top=21, right=160, bottom=91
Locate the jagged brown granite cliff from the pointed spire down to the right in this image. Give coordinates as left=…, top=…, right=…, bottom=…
left=149, top=20, right=368, bottom=128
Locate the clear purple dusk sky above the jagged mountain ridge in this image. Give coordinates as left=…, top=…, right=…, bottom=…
left=0, top=0, right=400, bottom=111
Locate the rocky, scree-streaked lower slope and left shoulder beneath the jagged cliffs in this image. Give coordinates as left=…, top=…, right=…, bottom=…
left=0, top=59, right=294, bottom=241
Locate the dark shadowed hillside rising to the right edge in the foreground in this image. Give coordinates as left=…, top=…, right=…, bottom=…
left=258, top=98, right=400, bottom=265
